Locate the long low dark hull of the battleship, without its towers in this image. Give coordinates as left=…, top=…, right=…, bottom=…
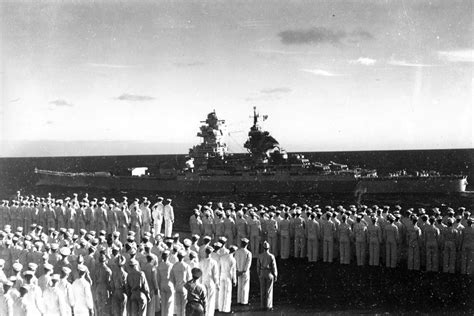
left=36, top=170, right=467, bottom=195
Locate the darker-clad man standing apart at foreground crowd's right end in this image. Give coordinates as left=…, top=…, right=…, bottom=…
left=257, top=241, right=278, bottom=311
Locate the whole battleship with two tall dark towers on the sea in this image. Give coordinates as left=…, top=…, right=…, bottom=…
left=35, top=108, right=467, bottom=196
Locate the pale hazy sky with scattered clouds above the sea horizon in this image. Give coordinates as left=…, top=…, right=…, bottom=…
left=0, top=0, right=474, bottom=157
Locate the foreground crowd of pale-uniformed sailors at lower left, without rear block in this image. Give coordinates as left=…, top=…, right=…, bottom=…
left=0, top=226, right=252, bottom=316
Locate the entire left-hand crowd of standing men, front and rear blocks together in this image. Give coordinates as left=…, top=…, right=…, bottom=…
left=0, top=192, right=277, bottom=316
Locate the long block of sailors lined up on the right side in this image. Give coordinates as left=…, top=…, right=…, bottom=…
left=189, top=204, right=474, bottom=274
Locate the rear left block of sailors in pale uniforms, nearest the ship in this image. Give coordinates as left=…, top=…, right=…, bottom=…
left=0, top=194, right=174, bottom=242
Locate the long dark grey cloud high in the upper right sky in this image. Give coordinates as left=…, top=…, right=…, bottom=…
left=278, top=27, right=373, bottom=45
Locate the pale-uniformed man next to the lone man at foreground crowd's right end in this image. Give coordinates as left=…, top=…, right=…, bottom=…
left=235, top=238, right=252, bottom=305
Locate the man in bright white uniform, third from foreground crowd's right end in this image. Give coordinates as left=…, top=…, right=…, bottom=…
left=217, top=245, right=237, bottom=313
